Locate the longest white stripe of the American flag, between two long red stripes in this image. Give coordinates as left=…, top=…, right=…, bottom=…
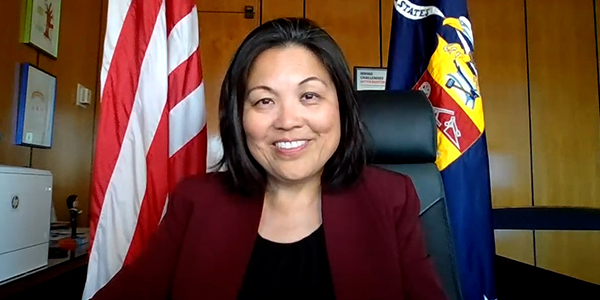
left=84, top=1, right=168, bottom=299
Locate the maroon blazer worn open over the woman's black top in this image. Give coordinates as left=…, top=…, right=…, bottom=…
left=89, top=167, right=446, bottom=300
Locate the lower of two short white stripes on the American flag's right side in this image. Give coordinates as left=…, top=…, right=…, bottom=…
left=169, top=81, right=206, bottom=157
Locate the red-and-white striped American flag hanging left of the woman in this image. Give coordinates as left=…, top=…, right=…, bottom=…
left=83, top=0, right=207, bottom=299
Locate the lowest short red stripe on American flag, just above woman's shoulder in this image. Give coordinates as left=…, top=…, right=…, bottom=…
left=169, top=126, right=207, bottom=191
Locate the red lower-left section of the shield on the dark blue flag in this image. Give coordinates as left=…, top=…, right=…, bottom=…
left=415, top=71, right=481, bottom=153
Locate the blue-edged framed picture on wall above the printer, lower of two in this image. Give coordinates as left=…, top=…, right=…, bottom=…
left=15, top=63, right=56, bottom=148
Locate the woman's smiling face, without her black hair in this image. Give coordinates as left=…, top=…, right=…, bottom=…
left=243, top=46, right=341, bottom=182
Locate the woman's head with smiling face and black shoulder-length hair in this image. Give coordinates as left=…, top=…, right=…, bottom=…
left=219, top=19, right=365, bottom=197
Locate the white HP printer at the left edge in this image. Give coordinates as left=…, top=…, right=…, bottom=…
left=0, top=165, right=52, bottom=284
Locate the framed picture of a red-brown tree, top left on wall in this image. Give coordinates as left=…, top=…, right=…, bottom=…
left=22, top=0, right=61, bottom=58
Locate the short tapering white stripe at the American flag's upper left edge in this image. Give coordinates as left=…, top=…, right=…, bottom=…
left=100, top=0, right=132, bottom=101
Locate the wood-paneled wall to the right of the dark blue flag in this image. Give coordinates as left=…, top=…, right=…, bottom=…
left=469, top=0, right=600, bottom=284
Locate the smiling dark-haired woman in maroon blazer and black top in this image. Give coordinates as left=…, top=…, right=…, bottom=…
left=95, top=19, right=446, bottom=300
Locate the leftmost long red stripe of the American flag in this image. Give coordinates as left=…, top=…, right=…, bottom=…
left=90, top=0, right=162, bottom=249
